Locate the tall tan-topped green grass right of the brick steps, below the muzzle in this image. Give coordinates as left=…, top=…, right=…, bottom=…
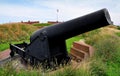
left=86, top=28, right=120, bottom=76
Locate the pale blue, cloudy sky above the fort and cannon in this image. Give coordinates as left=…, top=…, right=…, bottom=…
left=0, top=0, right=120, bottom=25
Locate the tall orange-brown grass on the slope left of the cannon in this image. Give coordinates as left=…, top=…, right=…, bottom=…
left=0, top=23, right=37, bottom=44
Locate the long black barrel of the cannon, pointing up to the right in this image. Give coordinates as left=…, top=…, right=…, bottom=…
left=30, top=8, right=113, bottom=41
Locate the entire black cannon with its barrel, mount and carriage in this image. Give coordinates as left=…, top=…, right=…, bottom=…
left=10, top=8, right=113, bottom=66
